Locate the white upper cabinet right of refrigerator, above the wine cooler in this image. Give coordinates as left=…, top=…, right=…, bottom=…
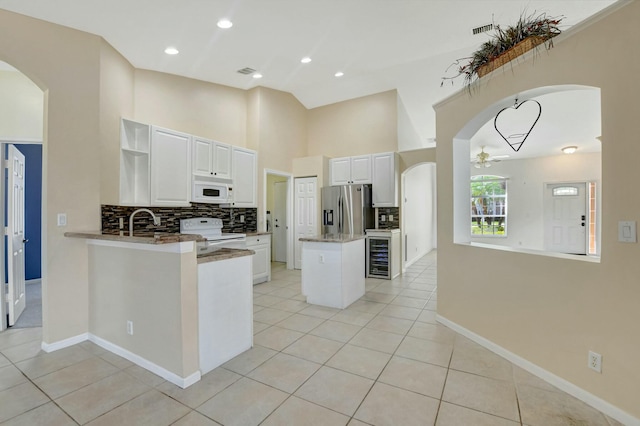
left=371, top=152, right=399, bottom=207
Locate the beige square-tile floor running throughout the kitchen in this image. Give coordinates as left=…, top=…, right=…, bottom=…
left=0, top=252, right=619, bottom=426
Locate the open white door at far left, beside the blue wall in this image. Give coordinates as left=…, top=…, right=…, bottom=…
left=6, top=145, right=27, bottom=326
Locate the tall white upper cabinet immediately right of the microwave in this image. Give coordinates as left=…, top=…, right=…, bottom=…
left=231, top=146, right=258, bottom=207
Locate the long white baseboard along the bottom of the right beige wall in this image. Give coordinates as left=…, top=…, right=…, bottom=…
left=436, top=315, right=640, bottom=426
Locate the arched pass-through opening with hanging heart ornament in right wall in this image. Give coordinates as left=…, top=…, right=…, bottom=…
left=453, top=85, right=602, bottom=260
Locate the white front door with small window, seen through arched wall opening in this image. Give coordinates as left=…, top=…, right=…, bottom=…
left=544, top=183, right=589, bottom=254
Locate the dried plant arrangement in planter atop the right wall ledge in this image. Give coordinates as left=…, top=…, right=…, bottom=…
left=441, top=13, right=563, bottom=87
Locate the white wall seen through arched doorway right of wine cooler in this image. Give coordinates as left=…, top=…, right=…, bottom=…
left=402, top=163, right=436, bottom=267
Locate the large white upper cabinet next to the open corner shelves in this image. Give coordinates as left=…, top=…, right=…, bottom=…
left=150, top=126, right=191, bottom=206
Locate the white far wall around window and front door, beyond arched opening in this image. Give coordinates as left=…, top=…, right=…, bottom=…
left=471, top=153, right=602, bottom=250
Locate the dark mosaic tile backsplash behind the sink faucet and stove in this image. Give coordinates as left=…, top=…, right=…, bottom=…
left=101, top=203, right=258, bottom=233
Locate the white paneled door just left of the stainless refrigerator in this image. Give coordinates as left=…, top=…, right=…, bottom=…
left=294, top=177, right=318, bottom=269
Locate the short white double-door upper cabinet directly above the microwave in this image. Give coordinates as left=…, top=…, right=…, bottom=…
left=192, top=136, right=231, bottom=179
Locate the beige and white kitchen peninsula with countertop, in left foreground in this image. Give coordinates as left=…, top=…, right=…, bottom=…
left=65, top=232, right=254, bottom=388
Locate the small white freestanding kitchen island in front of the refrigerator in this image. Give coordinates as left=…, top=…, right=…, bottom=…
left=300, top=234, right=365, bottom=309
